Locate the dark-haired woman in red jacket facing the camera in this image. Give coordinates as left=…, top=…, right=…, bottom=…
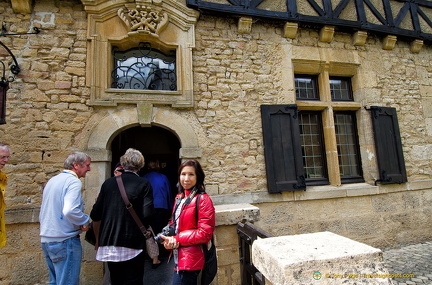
left=161, top=160, right=215, bottom=285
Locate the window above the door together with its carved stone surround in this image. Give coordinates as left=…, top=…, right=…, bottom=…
left=85, top=1, right=198, bottom=108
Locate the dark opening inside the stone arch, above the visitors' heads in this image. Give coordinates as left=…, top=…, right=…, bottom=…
left=110, top=127, right=180, bottom=197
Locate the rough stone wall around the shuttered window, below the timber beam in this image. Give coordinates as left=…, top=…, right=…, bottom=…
left=194, top=17, right=432, bottom=194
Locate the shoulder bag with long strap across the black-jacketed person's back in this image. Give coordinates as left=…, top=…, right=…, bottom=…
left=116, top=175, right=159, bottom=259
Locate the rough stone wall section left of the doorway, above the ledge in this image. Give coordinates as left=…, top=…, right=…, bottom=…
left=0, top=1, right=92, bottom=208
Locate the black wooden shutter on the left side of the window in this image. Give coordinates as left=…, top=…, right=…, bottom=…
left=261, top=105, right=306, bottom=193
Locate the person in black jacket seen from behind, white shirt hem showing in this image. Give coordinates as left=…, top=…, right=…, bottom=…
left=90, top=148, right=153, bottom=285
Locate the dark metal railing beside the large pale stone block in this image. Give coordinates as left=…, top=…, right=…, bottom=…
left=237, top=222, right=273, bottom=285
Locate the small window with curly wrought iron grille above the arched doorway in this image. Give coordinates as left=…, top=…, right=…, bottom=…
left=111, top=42, right=177, bottom=91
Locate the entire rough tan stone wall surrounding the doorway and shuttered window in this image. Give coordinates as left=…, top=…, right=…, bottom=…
left=0, top=0, right=432, bottom=285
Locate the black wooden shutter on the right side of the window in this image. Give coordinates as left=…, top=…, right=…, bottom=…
left=371, top=106, right=408, bottom=184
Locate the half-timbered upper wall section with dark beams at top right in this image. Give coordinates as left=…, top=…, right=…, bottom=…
left=187, top=0, right=432, bottom=43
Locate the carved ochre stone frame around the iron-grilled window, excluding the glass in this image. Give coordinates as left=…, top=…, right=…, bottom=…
left=81, top=0, right=199, bottom=108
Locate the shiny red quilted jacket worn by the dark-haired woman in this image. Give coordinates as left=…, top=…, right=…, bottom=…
left=170, top=190, right=215, bottom=270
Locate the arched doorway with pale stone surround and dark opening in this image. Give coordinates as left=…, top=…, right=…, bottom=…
left=82, top=104, right=202, bottom=284
